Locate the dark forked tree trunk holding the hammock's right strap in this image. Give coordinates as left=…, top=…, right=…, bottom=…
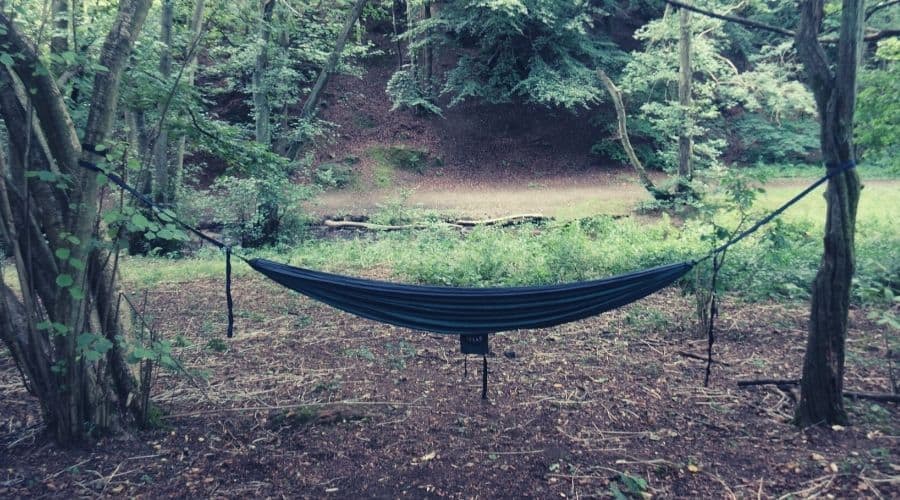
left=795, top=0, right=865, bottom=426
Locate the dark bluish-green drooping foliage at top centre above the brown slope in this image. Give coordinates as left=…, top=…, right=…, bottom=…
left=389, top=0, right=623, bottom=112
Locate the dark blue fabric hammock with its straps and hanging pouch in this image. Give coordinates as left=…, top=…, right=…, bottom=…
left=79, top=149, right=856, bottom=397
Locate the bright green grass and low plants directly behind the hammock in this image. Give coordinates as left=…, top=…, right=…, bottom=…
left=123, top=176, right=900, bottom=306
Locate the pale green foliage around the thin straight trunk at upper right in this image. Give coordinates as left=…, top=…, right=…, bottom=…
left=624, top=9, right=817, bottom=171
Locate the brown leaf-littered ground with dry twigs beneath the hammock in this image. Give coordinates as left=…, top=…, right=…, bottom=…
left=0, top=279, right=900, bottom=498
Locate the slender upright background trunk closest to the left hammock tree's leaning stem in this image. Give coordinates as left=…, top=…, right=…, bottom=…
left=153, top=0, right=175, bottom=205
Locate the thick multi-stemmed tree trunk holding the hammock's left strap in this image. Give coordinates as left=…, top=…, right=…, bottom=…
left=0, top=0, right=150, bottom=444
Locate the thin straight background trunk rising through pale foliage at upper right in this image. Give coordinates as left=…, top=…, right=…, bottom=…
left=678, top=9, right=694, bottom=192
